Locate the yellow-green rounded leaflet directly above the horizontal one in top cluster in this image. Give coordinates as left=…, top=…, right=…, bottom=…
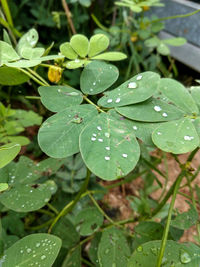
left=88, top=33, right=109, bottom=57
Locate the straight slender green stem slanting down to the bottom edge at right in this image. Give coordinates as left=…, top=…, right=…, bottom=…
left=156, top=175, right=183, bottom=267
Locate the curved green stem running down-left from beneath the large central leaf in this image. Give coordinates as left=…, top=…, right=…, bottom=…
left=48, top=169, right=91, bottom=233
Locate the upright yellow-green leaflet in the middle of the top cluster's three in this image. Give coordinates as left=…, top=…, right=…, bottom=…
left=70, top=34, right=89, bottom=58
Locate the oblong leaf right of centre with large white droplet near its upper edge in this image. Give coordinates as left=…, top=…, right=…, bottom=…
left=98, top=71, right=160, bottom=108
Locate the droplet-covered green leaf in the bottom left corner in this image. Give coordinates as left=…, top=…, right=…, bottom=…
left=0, top=234, right=61, bottom=267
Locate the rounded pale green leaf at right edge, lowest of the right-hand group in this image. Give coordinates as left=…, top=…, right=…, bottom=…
left=152, top=118, right=199, bottom=154
